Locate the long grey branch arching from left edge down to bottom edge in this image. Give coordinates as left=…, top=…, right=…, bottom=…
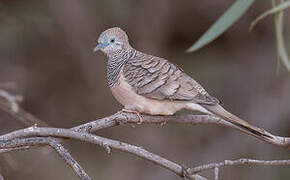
left=0, top=126, right=202, bottom=179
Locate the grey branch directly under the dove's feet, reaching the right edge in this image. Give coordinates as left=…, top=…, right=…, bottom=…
left=72, top=111, right=290, bottom=148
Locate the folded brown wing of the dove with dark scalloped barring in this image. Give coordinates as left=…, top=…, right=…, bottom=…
left=122, top=53, right=219, bottom=105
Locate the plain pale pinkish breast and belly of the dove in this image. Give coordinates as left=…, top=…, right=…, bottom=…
left=111, top=70, right=186, bottom=115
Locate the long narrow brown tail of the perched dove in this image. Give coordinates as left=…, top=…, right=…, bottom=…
left=202, top=104, right=272, bottom=138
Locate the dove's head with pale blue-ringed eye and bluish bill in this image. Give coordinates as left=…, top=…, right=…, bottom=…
left=94, top=27, right=130, bottom=55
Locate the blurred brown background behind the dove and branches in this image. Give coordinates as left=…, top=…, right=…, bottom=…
left=0, top=0, right=290, bottom=180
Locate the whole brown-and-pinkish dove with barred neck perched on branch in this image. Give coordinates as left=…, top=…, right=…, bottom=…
left=94, top=27, right=270, bottom=138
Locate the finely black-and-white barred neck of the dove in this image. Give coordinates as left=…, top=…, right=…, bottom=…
left=107, top=48, right=136, bottom=87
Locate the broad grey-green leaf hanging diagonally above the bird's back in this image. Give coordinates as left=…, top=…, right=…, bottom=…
left=187, top=0, right=254, bottom=52
